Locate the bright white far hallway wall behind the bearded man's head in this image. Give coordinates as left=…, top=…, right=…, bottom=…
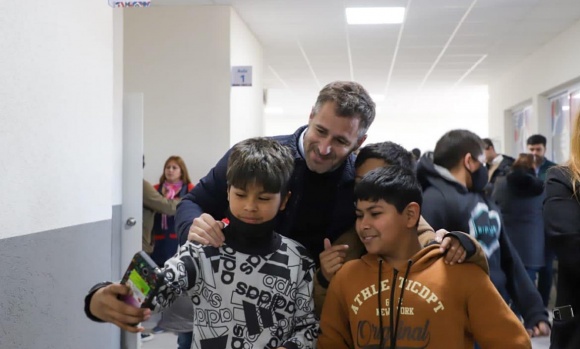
left=265, top=86, right=488, bottom=151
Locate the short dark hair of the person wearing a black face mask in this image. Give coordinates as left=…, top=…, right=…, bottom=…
left=433, top=130, right=484, bottom=170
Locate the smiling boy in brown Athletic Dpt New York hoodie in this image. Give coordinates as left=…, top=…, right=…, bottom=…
left=318, top=166, right=531, bottom=349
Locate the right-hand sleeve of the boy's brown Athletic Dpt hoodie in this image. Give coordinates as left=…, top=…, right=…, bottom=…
left=463, top=267, right=532, bottom=349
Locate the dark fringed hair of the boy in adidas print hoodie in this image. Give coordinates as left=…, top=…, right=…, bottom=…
left=226, top=138, right=294, bottom=194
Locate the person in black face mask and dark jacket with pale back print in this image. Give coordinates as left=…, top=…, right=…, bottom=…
left=417, top=130, right=550, bottom=336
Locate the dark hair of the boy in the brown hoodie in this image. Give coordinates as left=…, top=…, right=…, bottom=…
left=354, top=165, right=423, bottom=213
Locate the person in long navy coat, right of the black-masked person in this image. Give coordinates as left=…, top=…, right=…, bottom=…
left=492, top=154, right=545, bottom=284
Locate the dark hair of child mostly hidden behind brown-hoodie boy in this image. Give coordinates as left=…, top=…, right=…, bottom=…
left=354, top=142, right=415, bottom=170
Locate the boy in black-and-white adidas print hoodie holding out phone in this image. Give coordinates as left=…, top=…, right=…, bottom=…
left=85, top=138, right=318, bottom=349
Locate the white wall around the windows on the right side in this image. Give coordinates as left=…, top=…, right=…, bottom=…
left=489, top=21, right=580, bottom=154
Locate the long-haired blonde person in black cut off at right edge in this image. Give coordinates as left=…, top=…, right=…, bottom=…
left=544, top=115, right=580, bottom=349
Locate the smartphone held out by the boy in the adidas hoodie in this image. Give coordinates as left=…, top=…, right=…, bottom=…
left=121, top=251, right=165, bottom=309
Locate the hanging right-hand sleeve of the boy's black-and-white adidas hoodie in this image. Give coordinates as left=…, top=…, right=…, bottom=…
left=280, top=261, right=319, bottom=349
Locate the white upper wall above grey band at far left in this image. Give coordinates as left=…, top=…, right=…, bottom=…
left=0, top=0, right=113, bottom=239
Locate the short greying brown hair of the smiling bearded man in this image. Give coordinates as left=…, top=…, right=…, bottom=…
left=312, top=81, right=375, bottom=138
